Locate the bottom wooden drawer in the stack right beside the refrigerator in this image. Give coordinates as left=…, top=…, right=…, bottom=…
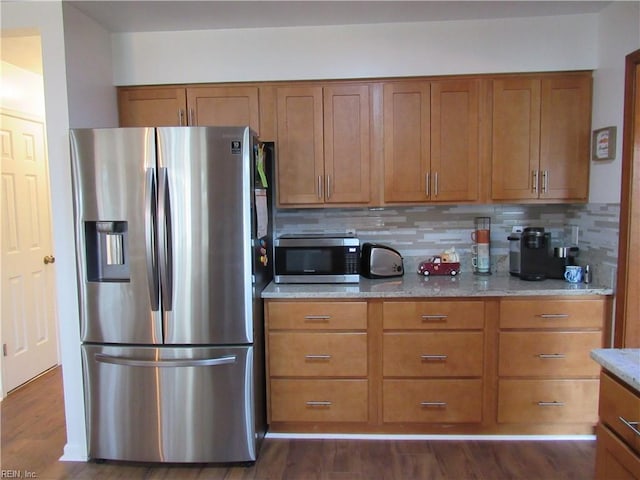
left=270, top=379, right=369, bottom=422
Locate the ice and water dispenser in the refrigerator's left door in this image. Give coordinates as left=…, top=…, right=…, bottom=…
left=84, top=221, right=130, bottom=282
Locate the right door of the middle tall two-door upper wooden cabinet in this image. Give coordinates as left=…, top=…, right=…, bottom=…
left=431, top=80, right=480, bottom=201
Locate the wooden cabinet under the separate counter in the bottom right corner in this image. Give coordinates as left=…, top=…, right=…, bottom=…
left=596, top=370, right=640, bottom=480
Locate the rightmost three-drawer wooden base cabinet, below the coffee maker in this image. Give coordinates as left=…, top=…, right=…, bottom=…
left=497, top=299, right=604, bottom=425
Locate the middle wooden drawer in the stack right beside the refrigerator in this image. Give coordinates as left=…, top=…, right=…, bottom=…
left=269, top=332, right=367, bottom=377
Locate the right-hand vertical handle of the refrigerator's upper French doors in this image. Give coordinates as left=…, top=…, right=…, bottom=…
left=158, top=167, right=173, bottom=312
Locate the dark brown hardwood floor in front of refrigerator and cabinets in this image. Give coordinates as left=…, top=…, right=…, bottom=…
left=0, top=368, right=595, bottom=480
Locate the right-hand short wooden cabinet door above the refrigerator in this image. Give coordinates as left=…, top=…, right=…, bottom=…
left=187, top=87, right=260, bottom=133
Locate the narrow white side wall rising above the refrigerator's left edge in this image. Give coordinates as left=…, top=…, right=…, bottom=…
left=63, top=3, right=118, bottom=128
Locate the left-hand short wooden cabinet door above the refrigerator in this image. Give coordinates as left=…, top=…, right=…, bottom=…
left=118, top=87, right=187, bottom=127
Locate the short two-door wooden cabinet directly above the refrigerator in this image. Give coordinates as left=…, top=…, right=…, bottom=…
left=118, top=86, right=260, bottom=133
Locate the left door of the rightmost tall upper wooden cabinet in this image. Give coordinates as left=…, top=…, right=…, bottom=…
left=491, top=78, right=540, bottom=200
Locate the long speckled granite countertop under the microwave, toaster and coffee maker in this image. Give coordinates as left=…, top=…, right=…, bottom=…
left=262, top=272, right=613, bottom=298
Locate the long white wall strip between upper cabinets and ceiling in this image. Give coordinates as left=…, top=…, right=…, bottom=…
left=113, top=14, right=597, bottom=85
